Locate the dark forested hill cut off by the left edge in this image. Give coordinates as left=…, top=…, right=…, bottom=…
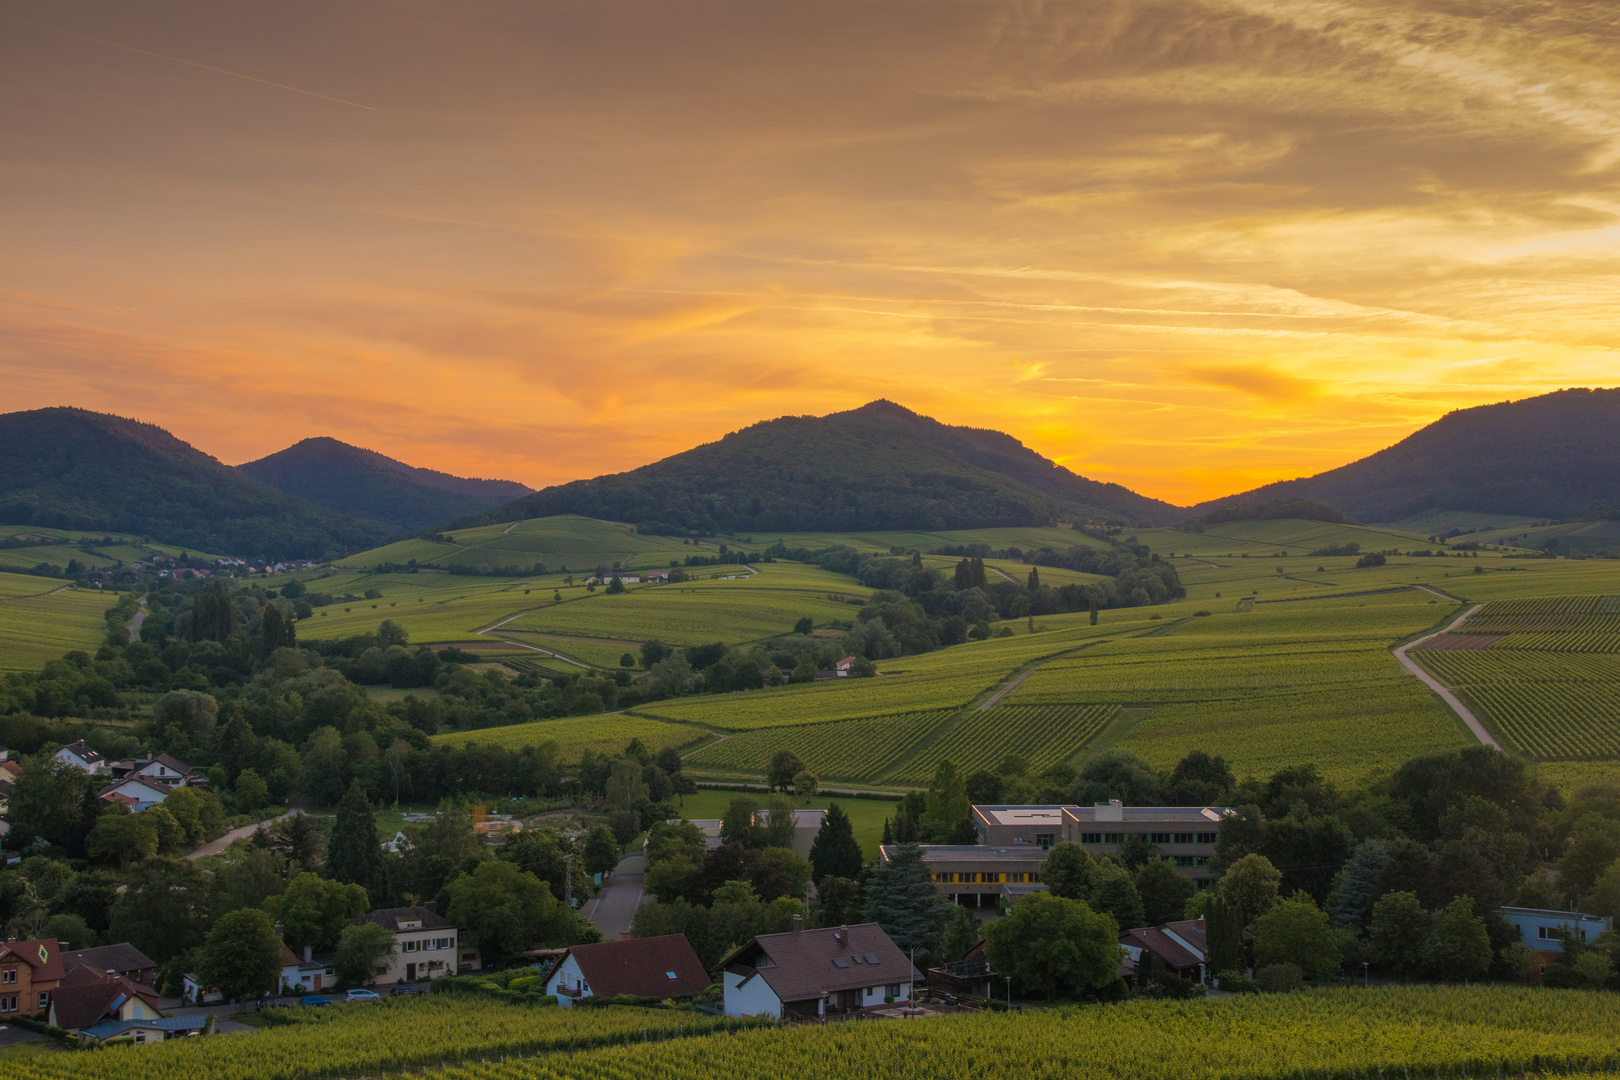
left=0, top=408, right=397, bottom=559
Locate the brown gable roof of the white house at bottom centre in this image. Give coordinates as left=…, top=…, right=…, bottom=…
left=726, top=923, right=920, bottom=1002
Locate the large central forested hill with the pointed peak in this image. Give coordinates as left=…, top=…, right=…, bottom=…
left=467, top=402, right=1183, bottom=533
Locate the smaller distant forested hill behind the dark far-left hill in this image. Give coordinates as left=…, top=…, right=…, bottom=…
left=237, top=437, right=530, bottom=531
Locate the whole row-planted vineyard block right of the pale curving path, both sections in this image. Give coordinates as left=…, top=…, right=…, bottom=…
left=1413, top=596, right=1620, bottom=761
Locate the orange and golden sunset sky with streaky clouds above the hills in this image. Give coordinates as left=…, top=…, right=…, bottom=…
left=0, top=0, right=1620, bottom=504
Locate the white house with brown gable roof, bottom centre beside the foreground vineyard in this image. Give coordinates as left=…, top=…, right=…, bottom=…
left=721, top=915, right=919, bottom=1020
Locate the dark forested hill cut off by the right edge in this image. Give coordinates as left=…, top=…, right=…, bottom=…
left=1192, top=389, right=1620, bottom=521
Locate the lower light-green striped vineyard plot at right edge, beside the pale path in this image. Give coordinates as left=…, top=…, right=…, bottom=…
left=1414, top=644, right=1620, bottom=761
